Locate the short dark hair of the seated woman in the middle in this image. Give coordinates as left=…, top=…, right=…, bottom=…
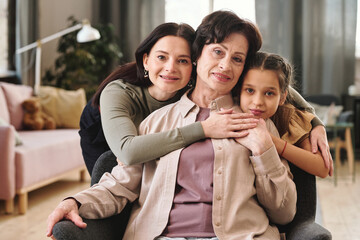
left=192, top=10, right=262, bottom=93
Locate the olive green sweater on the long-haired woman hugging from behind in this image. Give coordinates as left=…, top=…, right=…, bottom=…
left=100, top=80, right=321, bottom=165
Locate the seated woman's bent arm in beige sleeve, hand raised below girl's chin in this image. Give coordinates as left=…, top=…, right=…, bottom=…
left=235, top=119, right=297, bottom=224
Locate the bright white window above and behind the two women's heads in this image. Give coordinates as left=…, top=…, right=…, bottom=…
left=165, top=0, right=256, bottom=29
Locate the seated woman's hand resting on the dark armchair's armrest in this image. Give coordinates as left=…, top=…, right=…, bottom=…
left=46, top=198, right=86, bottom=239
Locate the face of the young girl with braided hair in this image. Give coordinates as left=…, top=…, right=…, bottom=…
left=240, top=69, right=286, bottom=119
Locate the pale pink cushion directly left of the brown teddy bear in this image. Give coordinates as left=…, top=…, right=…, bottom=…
left=1, top=83, right=33, bottom=130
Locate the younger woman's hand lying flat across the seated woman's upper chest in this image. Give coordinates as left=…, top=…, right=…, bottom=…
left=201, top=109, right=259, bottom=138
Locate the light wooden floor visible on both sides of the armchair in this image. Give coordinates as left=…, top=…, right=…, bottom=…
left=0, top=160, right=360, bottom=240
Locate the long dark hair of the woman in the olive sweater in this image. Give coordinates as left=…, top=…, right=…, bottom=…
left=92, top=23, right=195, bottom=106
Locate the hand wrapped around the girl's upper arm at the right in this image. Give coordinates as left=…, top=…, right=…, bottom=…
left=310, top=125, right=334, bottom=176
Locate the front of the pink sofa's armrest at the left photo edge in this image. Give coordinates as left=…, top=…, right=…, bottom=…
left=0, top=125, right=16, bottom=200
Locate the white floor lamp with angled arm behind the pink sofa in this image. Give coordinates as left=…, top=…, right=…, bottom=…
left=16, top=20, right=101, bottom=95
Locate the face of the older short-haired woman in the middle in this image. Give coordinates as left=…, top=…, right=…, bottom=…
left=196, top=33, right=249, bottom=98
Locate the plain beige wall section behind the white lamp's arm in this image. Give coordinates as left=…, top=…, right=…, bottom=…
left=38, top=0, right=93, bottom=76
